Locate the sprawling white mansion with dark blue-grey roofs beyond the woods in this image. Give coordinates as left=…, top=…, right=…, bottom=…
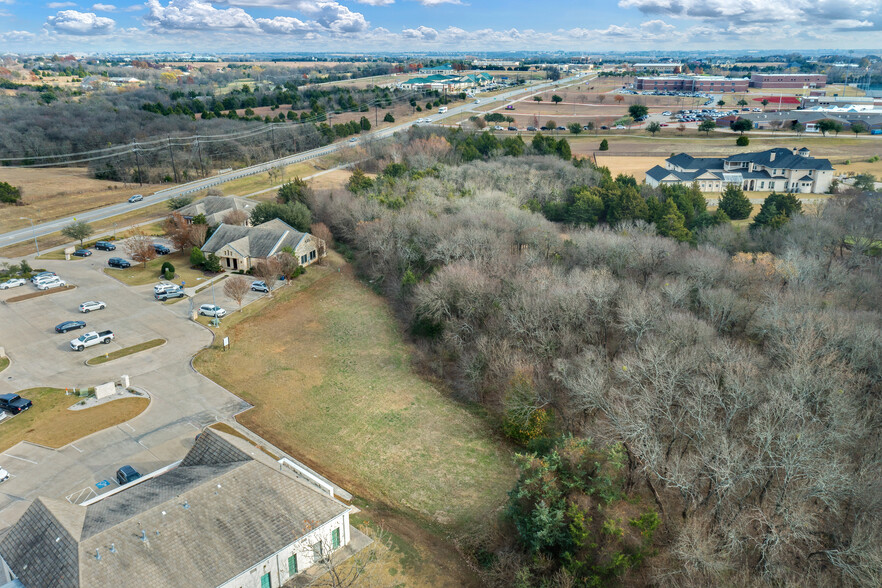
left=646, top=147, right=833, bottom=194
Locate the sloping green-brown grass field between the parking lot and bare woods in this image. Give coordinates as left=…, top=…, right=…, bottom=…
left=194, top=254, right=514, bottom=585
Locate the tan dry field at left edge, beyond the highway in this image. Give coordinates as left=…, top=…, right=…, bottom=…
left=0, top=167, right=168, bottom=232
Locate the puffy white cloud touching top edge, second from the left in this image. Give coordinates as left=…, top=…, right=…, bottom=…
left=144, top=0, right=258, bottom=31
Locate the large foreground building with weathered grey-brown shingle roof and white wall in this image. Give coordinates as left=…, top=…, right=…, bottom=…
left=0, top=429, right=369, bottom=588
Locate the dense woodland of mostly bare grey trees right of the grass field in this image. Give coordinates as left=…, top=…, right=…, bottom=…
left=310, top=129, right=882, bottom=586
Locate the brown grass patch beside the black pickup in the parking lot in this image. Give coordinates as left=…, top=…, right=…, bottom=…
left=0, top=388, right=150, bottom=451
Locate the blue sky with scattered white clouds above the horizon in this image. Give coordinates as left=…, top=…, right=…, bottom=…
left=0, top=0, right=882, bottom=53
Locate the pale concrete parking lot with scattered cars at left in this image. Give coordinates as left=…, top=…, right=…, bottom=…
left=0, top=240, right=259, bottom=529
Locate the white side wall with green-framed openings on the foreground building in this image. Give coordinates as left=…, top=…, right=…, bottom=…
left=218, top=510, right=350, bottom=588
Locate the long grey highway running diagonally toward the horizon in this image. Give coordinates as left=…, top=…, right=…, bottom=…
left=0, top=76, right=581, bottom=247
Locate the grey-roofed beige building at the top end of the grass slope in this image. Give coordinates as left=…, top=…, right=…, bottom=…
left=202, top=219, right=326, bottom=271
